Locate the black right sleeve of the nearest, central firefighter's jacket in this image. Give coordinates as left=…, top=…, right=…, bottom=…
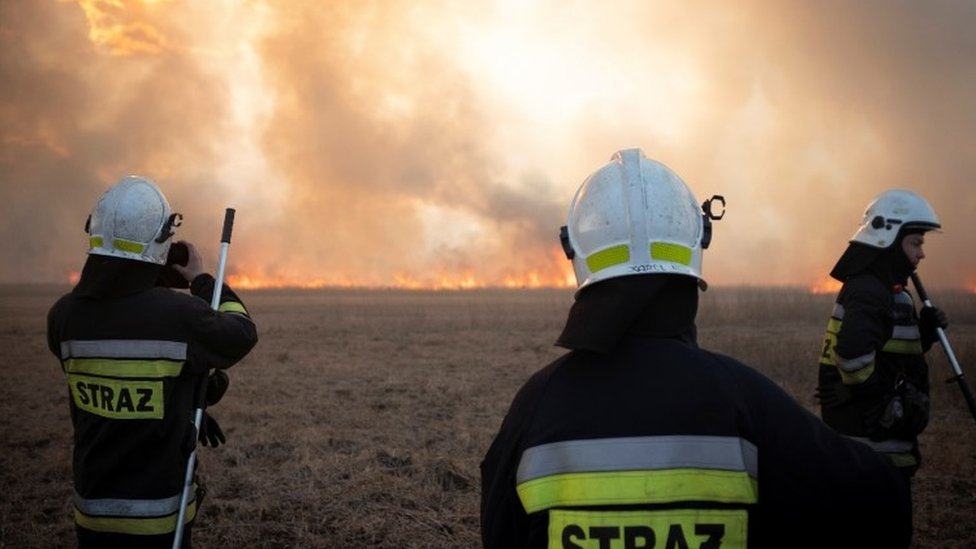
left=735, top=358, right=912, bottom=548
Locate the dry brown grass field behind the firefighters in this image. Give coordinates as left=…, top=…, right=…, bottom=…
left=0, top=286, right=976, bottom=549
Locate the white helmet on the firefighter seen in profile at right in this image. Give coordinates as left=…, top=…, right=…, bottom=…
left=850, top=189, right=942, bottom=248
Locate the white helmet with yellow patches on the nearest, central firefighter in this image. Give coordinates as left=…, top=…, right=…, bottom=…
left=560, top=149, right=725, bottom=291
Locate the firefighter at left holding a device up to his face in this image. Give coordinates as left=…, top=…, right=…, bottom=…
left=47, top=176, right=257, bottom=548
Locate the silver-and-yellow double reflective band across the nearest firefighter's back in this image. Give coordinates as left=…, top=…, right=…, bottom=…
left=516, top=436, right=758, bottom=513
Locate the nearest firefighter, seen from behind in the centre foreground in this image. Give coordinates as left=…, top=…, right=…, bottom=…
left=481, top=149, right=911, bottom=549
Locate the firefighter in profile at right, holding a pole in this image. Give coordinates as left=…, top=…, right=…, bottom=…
left=817, top=189, right=948, bottom=478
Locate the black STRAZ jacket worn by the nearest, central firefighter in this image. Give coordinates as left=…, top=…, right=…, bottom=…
left=481, top=330, right=911, bottom=549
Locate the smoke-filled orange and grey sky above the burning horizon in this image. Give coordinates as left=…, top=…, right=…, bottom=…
left=0, top=0, right=976, bottom=291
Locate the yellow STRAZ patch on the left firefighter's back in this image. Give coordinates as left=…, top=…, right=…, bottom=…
left=67, top=374, right=165, bottom=419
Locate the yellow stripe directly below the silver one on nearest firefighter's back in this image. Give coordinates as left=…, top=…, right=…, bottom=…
left=516, top=468, right=758, bottom=513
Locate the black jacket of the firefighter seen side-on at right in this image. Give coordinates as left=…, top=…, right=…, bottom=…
left=818, top=273, right=933, bottom=471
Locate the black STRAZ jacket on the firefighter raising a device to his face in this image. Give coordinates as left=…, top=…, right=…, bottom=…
left=48, top=258, right=257, bottom=536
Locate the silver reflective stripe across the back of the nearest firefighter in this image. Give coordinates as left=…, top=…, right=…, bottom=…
left=517, top=435, right=758, bottom=484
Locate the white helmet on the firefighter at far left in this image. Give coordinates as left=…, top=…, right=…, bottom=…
left=85, top=175, right=181, bottom=265
